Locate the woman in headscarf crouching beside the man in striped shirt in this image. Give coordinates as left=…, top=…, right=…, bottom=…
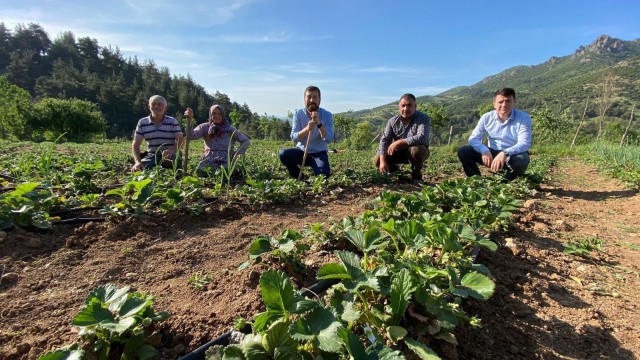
left=184, top=104, right=250, bottom=176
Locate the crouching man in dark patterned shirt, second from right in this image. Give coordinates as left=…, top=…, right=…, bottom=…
left=373, top=94, right=431, bottom=184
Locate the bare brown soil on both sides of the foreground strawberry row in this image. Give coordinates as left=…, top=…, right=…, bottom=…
left=0, top=159, right=640, bottom=359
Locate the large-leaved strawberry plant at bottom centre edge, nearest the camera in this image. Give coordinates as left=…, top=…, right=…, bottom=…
left=206, top=270, right=404, bottom=360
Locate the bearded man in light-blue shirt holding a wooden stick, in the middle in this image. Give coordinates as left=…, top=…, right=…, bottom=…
left=279, top=86, right=333, bottom=179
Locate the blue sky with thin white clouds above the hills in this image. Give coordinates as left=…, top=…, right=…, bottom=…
left=0, top=0, right=640, bottom=116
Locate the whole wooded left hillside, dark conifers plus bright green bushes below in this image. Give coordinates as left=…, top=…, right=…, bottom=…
left=0, top=23, right=291, bottom=142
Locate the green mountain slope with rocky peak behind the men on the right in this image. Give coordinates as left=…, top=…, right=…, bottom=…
left=345, top=35, right=640, bottom=142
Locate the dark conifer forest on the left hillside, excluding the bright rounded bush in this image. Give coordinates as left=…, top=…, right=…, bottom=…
left=0, top=24, right=264, bottom=141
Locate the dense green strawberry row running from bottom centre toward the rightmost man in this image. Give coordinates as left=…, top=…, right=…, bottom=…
left=240, top=172, right=552, bottom=359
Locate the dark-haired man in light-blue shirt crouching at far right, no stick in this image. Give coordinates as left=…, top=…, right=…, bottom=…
left=458, top=88, right=531, bottom=181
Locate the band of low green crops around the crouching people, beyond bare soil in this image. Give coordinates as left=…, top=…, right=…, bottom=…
left=0, top=142, right=459, bottom=229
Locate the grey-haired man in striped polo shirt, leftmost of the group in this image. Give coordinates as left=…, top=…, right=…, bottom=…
left=131, top=95, right=184, bottom=171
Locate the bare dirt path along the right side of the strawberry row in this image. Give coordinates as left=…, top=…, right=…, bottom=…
left=458, top=159, right=640, bottom=359
